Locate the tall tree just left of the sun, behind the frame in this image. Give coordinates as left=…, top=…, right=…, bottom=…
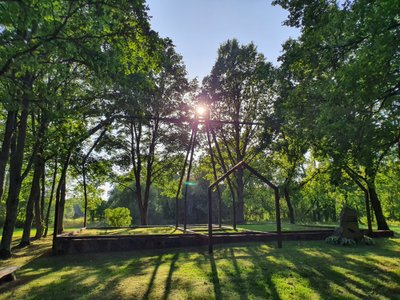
left=108, top=40, right=191, bottom=225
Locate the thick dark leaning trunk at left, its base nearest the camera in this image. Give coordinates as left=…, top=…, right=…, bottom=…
left=0, top=98, right=28, bottom=259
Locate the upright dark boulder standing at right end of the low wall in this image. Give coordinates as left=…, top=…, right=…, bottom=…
left=335, top=206, right=363, bottom=242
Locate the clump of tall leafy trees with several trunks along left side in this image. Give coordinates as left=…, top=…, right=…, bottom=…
left=0, top=0, right=158, bottom=258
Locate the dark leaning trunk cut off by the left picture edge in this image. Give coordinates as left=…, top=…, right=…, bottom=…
left=0, top=111, right=17, bottom=200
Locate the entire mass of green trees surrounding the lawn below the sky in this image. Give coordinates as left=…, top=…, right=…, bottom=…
left=0, top=0, right=400, bottom=258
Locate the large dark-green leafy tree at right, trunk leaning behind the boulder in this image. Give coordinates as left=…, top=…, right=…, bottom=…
left=274, top=0, right=400, bottom=229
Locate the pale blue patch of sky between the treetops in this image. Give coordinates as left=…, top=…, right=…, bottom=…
left=146, top=0, right=299, bottom=82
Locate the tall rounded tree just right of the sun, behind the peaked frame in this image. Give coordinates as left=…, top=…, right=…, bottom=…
left=202, top=39, right=275, bottom=223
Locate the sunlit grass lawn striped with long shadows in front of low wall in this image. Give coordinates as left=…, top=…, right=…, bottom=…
left=0, top=226, right=400, bottom=300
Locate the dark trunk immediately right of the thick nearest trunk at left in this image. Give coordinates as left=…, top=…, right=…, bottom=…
left=19, top=155, right=43, bottom=247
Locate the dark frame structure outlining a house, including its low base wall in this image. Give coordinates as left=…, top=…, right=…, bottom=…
left=53, top=108, right=393, bottom=253
